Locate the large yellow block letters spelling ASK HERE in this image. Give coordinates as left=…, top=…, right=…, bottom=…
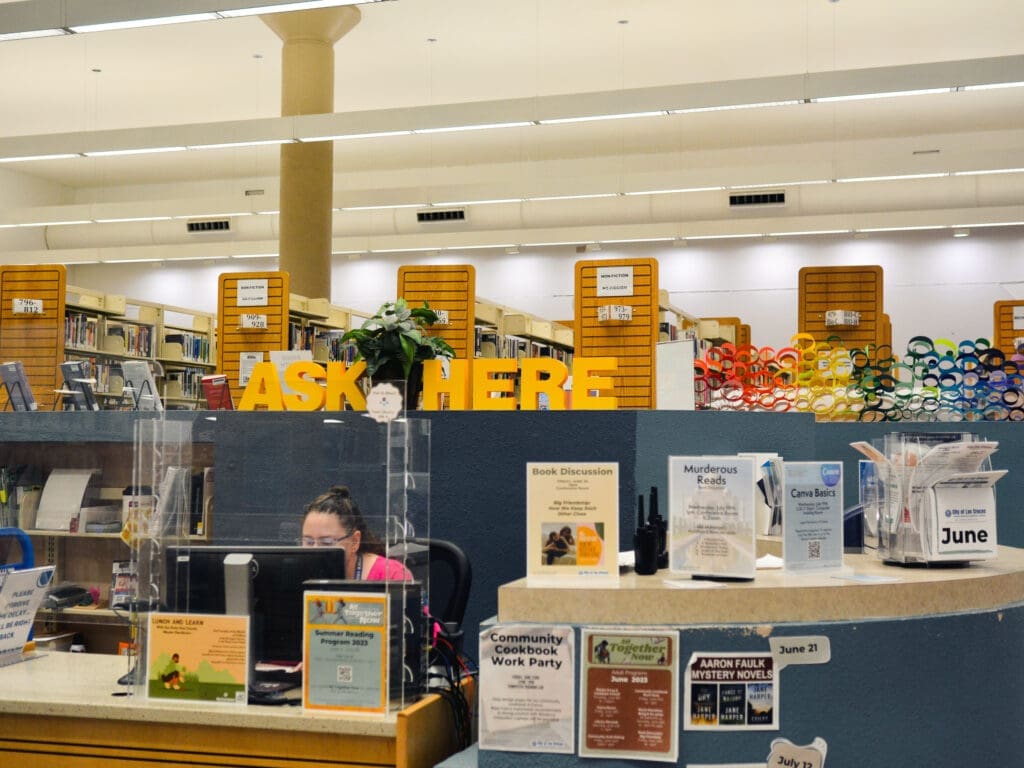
left=239, top=357, right=617, bottom=411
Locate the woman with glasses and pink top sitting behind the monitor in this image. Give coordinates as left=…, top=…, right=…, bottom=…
left=302, top=485, right=413, bottom=582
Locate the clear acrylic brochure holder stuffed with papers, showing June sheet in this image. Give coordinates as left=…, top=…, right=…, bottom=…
left=853, top=432, right=1006, bottom=564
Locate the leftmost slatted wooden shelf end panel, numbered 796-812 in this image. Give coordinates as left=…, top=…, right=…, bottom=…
left=0, top=264, right=67, bottom=411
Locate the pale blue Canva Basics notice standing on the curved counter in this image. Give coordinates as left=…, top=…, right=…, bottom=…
left=782, top=462, right=843, bottom=571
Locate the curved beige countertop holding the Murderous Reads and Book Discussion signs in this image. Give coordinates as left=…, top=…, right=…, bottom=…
left=498, top=547, right=1024, bottom=625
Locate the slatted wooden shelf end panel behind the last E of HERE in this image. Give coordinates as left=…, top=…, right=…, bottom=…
left=575, top=258, right=659, bottom=409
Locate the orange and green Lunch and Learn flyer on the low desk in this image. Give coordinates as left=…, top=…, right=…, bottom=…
left=145, top=613, right=249, bottom=705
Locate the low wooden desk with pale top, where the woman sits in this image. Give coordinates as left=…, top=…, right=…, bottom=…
left=0, top=653, right=456, bottom=768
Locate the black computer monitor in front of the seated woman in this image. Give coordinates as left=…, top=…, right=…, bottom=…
left=163, top=545, right=345, bottom=662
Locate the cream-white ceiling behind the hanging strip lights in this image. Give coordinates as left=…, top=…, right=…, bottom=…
left=0, top=0, right=1024, bottom=262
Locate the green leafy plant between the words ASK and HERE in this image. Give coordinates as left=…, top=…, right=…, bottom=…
left=341, top=299, right=455, bottom=391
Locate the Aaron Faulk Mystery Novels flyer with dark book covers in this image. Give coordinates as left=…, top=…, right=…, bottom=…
left=683, top=652, right=779, bottom=731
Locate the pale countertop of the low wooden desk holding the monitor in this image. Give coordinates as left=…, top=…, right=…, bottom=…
left=0, top=652, right=397, bottom=738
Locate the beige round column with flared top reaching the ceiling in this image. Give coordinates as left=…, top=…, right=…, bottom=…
left=262, top=6, right=359, bottom=298
